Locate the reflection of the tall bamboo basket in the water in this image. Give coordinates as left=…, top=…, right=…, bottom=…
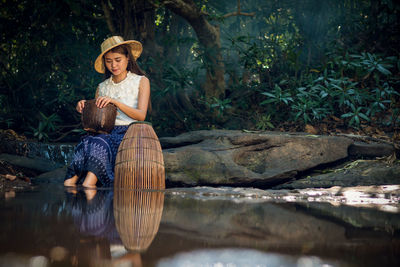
left=114, top=189, right=164, bottom=252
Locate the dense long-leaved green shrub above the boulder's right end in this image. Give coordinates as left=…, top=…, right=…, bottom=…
left=261, top=53, right=399, bottom=128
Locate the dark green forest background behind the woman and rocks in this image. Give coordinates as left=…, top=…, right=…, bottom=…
left=0, top=0, right=400, bottom=142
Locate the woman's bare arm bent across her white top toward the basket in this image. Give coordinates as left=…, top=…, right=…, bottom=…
left=96, top=76, right=150, bottom=121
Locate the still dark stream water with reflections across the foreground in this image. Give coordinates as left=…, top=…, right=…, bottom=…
left=0, top=184, right=400, bottom=267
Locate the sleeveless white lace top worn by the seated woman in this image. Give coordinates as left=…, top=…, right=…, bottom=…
left=99, top=72, right=143, bottom=125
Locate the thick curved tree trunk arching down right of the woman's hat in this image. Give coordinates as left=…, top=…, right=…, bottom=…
left=162, top=0, right=225, bottom=99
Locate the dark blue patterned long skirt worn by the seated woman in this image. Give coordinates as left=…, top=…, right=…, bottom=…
left=64, top=125, right=129, bottom=187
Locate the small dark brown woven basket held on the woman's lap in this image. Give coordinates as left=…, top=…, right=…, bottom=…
left=82, top=99, right=117, bottom=133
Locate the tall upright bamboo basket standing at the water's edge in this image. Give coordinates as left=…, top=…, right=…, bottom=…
left=114, top=122, right=165, bottom=190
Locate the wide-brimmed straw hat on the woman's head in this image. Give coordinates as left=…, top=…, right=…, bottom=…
left=94, top=36, right=143, bottom=73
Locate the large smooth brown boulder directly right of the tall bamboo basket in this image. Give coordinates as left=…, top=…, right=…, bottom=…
left=160, top=130, right=353, bottom=186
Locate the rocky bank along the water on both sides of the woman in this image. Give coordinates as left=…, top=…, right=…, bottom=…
left=0, top=130, right=400, bottom=188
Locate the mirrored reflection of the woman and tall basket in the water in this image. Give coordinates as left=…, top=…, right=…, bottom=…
left=68, top=189, right=164, bottom=266
